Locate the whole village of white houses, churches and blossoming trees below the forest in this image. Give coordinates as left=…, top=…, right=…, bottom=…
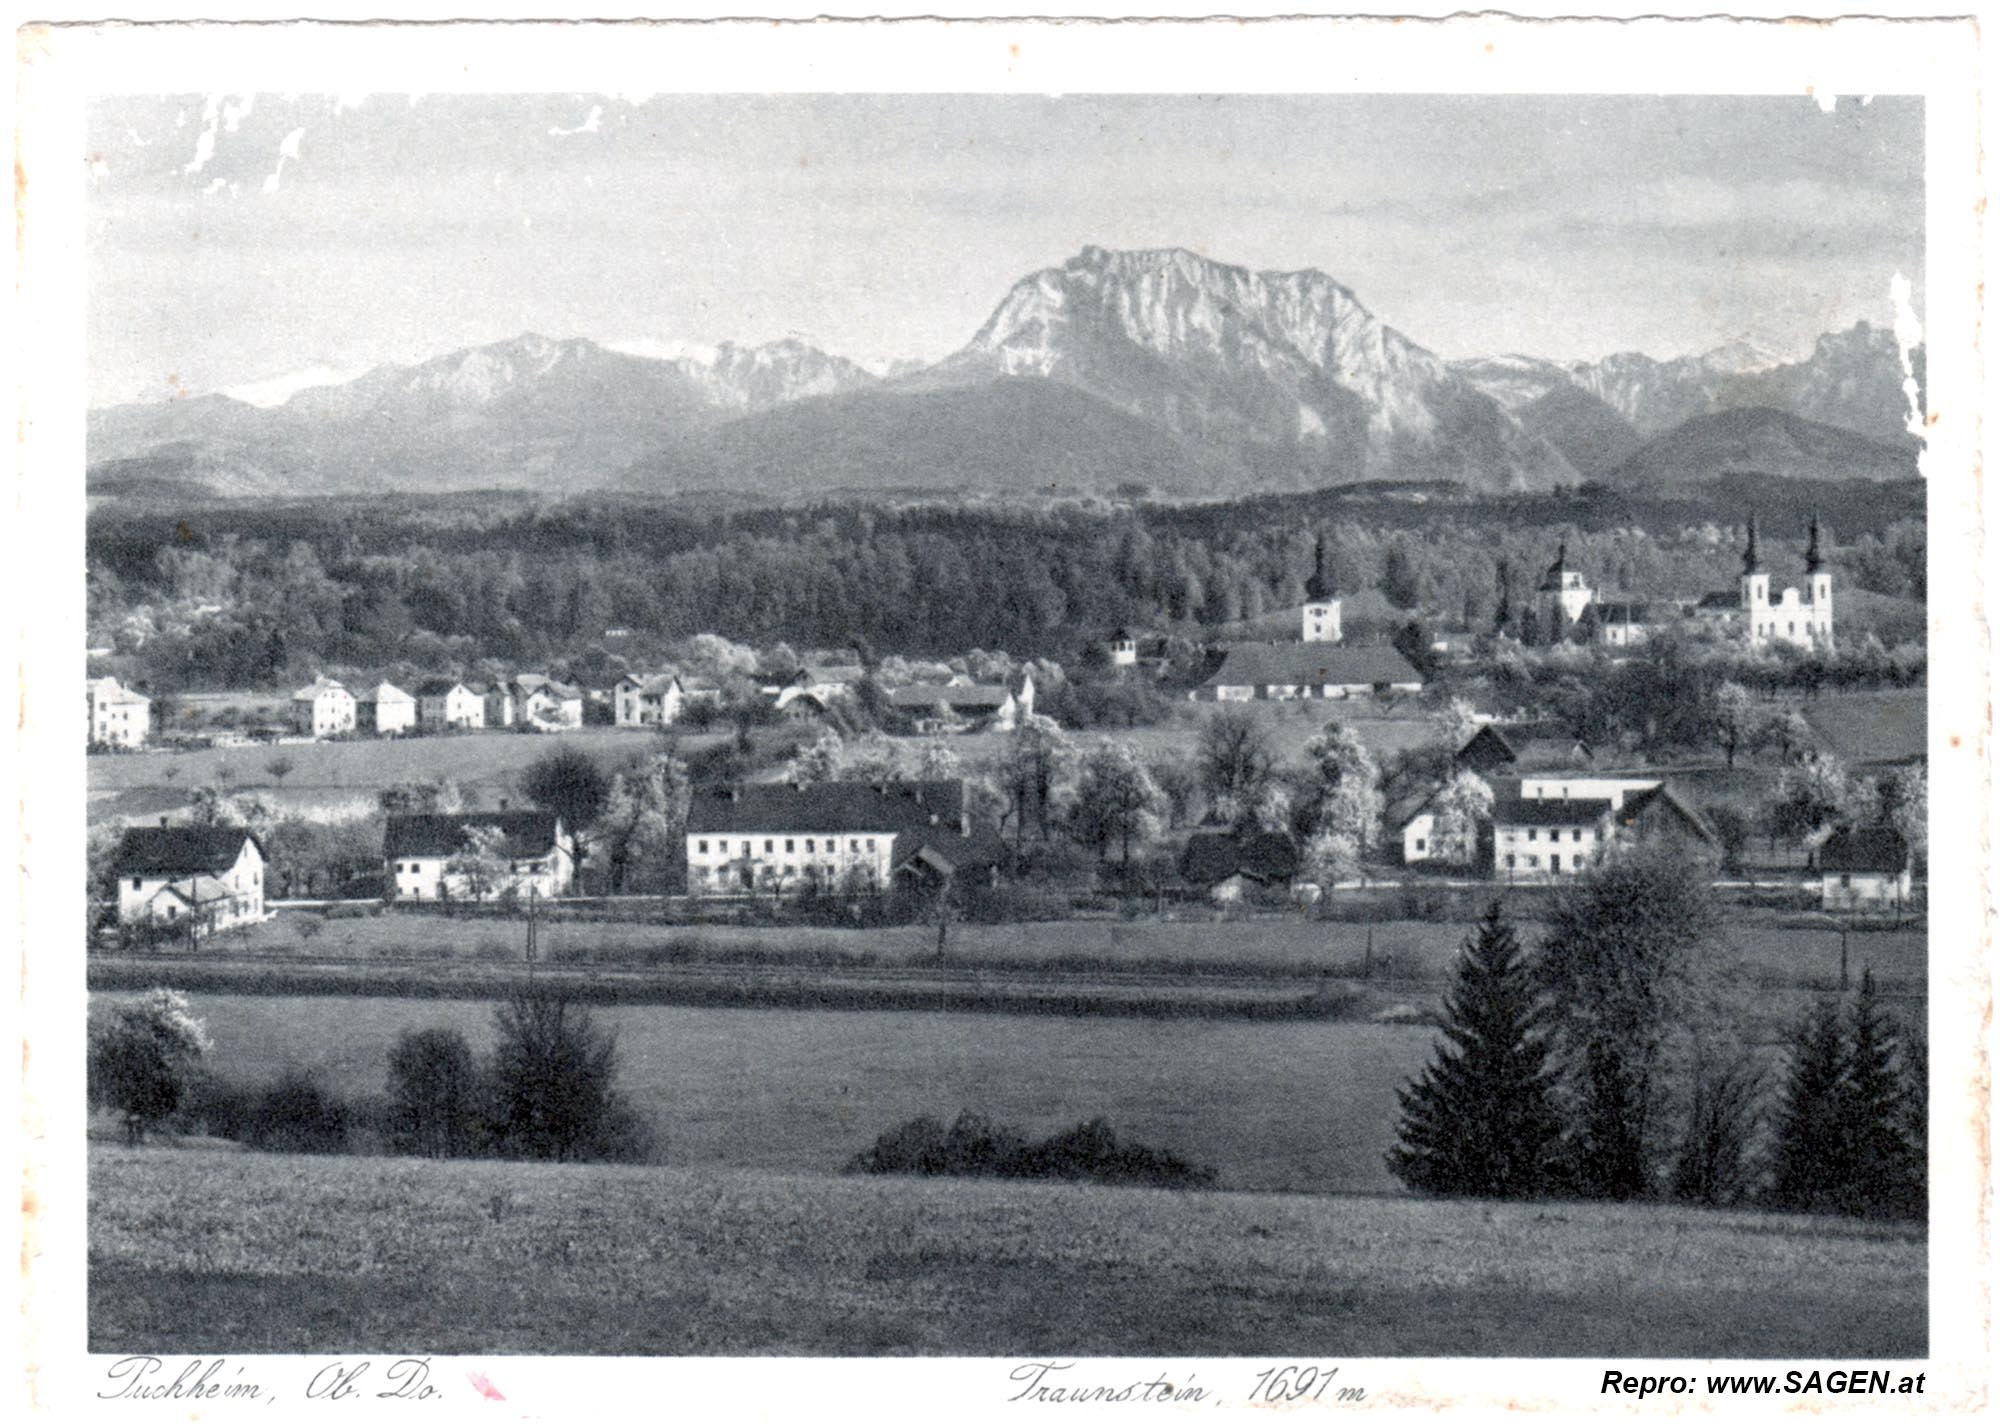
left=88, top=520, right=1924, bottom=944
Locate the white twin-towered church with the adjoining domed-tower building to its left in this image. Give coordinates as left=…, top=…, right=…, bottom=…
left=1534, top=516, right=1834, bottom=648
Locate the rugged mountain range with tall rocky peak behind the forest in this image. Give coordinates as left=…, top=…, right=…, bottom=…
left=90, top=248, right=1922, bottom=498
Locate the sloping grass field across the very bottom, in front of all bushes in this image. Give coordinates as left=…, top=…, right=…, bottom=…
left=88, top=1146, right=1926, bottom=1360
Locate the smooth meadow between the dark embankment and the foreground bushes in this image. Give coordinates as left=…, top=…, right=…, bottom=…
left=172, top=992, right=1434, bottom=1192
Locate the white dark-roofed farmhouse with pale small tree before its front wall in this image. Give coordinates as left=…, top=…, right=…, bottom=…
left=382, top=808, right=576, bottom=902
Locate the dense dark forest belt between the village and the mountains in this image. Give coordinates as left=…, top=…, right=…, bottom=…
left=88, top=482, right=1924, bottom=688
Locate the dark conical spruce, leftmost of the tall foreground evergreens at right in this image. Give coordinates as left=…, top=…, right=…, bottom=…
left=1388, top=902, right=1562, bottom=1198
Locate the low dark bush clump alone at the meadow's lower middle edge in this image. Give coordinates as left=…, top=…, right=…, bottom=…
left=848, top=1112, right=1216, bottom=1190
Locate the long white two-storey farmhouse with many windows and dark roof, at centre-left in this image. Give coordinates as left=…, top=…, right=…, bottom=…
left=688, top=778, right=1000, bottom=896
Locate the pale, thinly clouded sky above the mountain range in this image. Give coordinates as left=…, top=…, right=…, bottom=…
left=86, top=94, right=1924, bottom=404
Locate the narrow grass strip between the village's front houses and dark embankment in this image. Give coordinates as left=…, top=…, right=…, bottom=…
left=214, top=912, right=1926, bottom=994
